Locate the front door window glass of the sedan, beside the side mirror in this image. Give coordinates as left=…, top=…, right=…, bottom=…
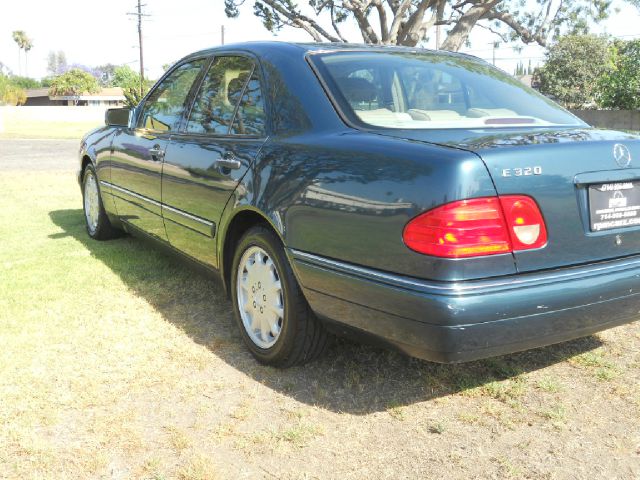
left=138, top=59, right=206, bottom=132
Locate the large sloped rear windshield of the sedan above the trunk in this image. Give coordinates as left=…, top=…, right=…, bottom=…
left=309, top=51, right=585, bottom=129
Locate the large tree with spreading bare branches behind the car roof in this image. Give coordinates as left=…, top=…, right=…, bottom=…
left=224, top=0, right=612, bottom=51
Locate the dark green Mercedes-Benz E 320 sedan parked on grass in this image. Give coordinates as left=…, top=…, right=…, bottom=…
left=78, top=42, right=640, bottom=366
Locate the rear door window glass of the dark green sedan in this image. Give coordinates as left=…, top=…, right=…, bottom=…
left=186, top=56, right=264, bottom=135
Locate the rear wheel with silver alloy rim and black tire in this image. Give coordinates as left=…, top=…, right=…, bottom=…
left=231, top=226, right=328, bottom=367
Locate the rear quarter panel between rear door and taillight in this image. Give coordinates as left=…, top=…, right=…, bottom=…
left=231, top=131, right=515, bottom=280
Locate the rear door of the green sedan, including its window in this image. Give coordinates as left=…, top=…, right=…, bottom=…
left=162, top=54, right=266, bottom=267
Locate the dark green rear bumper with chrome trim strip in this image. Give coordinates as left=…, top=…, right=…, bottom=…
left=289, top=250, right=640, bottom=363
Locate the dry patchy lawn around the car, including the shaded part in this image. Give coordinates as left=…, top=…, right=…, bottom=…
left=0, top=164, right=640, bottom=480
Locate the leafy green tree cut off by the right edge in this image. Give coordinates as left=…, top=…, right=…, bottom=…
left=598, top=40, right=640, bottom=110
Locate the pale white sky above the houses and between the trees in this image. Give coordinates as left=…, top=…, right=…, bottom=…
left=0, top=0, right=640, bottom=78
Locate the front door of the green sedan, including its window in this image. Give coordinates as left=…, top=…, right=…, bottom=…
left=109, top=59, right=207, bottom=240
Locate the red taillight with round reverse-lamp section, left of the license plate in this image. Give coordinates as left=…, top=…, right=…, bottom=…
left=402, top=195, right=547, bottom=258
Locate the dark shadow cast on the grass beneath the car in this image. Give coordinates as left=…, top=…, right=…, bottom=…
left=49, top=209, right=601, bottom=414
